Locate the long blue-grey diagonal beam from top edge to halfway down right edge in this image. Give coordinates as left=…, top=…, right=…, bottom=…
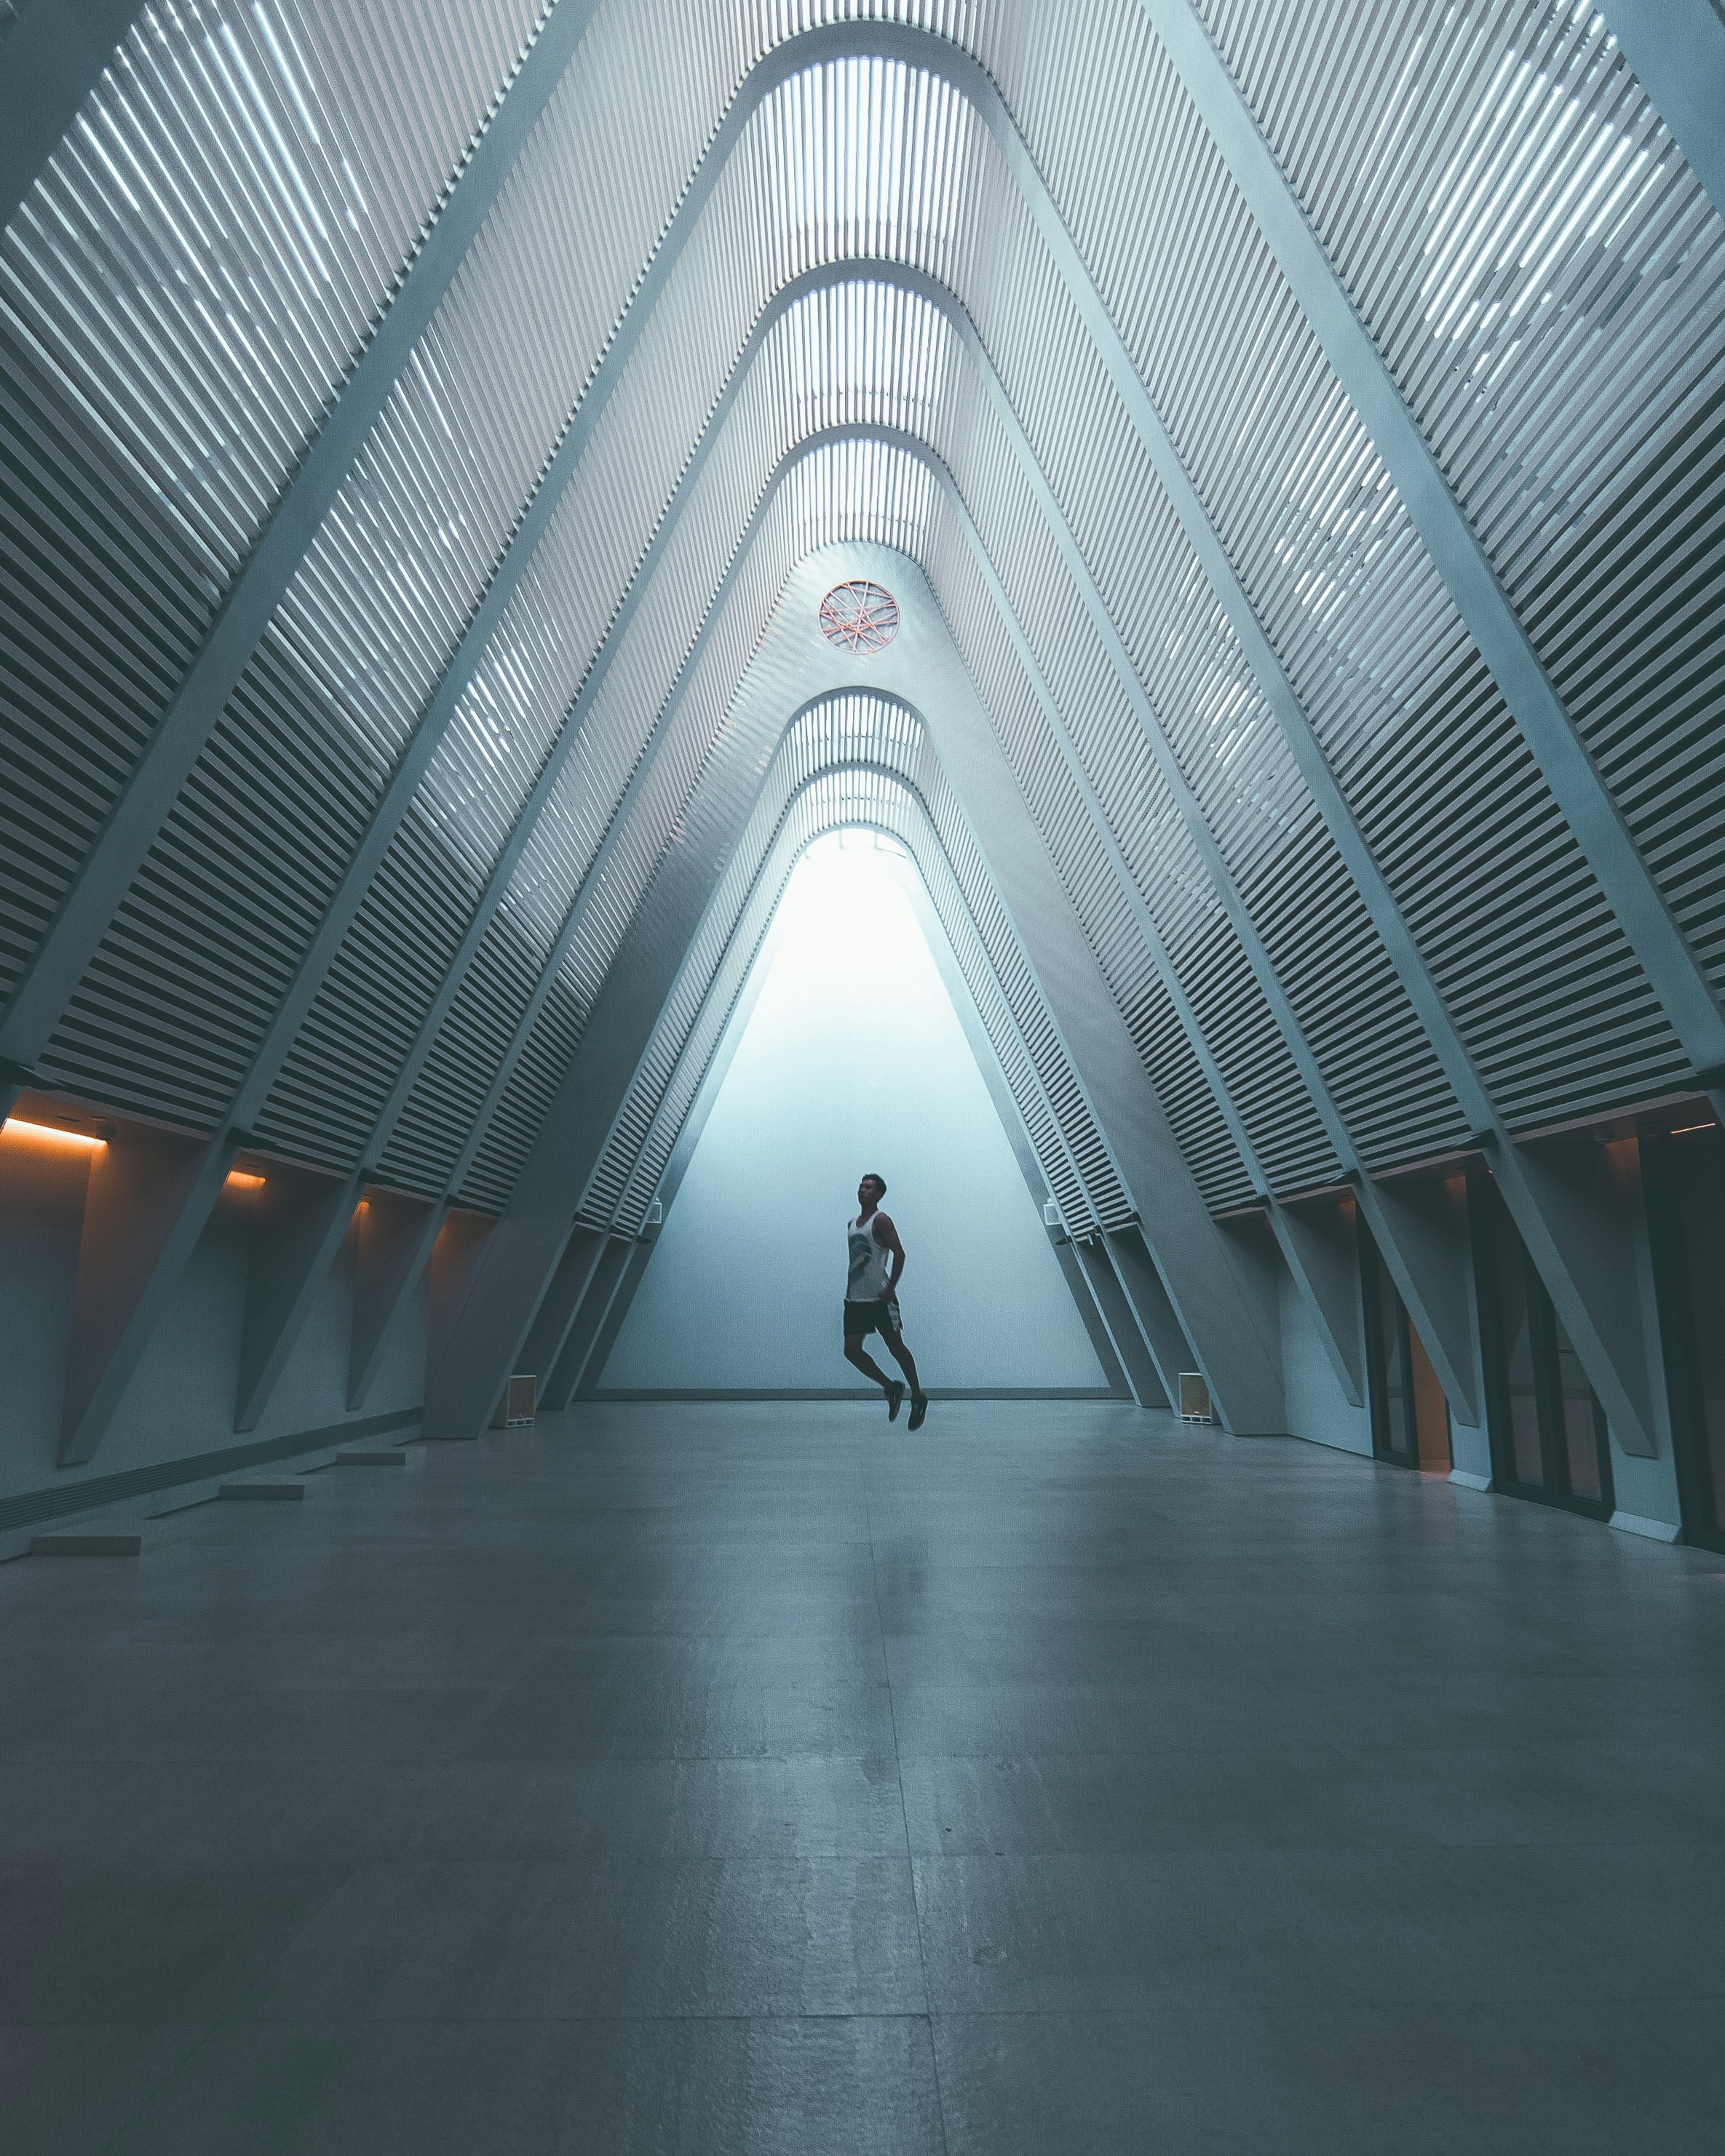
left=1141, top=0, right=1725, bottom=1074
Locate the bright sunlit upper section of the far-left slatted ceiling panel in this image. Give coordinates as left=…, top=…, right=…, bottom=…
left=0, top=0, right=535, bottom=582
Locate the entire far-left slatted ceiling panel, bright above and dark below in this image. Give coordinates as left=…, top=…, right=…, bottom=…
left=0, top=0, right=545, bottom=995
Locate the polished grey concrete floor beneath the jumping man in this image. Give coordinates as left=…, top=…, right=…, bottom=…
left=0, top=1404, right=1725, bottom=2156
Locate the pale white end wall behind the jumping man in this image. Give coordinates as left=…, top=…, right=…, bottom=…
left=602, top=835, right=1104, bottom=1391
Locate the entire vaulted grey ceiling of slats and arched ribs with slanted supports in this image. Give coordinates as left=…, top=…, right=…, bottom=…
left=0, top=0, right=1725, bottom=1511
